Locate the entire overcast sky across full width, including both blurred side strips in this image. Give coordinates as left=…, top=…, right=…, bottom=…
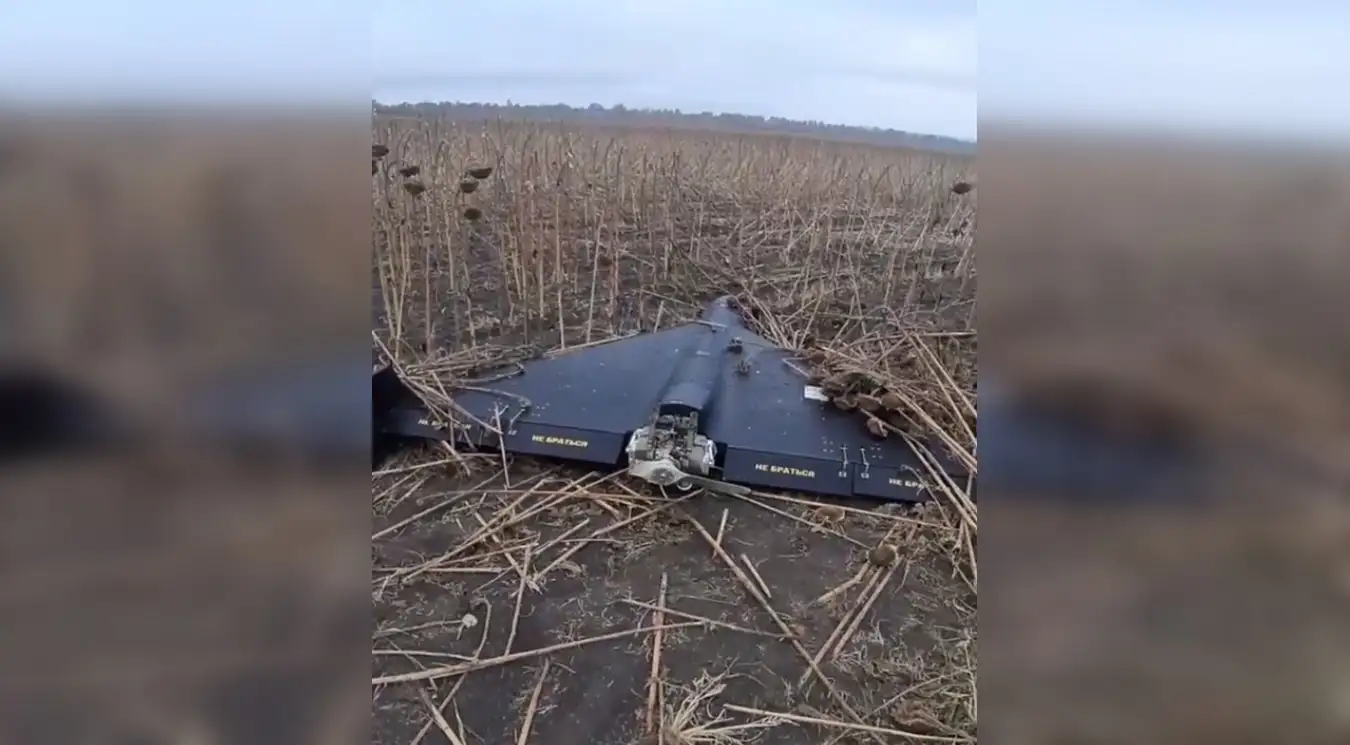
left=0, top=0, right=1350, bottom=138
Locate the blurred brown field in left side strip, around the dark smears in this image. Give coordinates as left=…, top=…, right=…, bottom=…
left=0, top=114, right=370, bottom=744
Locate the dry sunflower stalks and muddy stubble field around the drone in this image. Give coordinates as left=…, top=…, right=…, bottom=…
left=371, top=119, right=977, bottom=745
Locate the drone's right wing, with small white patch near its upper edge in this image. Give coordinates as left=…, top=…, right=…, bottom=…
left=707, top=327, right=965, bottom=502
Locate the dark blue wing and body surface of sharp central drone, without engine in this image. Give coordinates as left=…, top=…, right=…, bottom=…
left=405, top=298, right=966, bottom=501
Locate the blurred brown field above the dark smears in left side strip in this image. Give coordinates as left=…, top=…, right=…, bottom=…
left=0, top=112, right=369, bottom=377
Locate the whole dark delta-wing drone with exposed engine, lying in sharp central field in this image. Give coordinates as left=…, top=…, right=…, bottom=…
left=373, top=297, right=965, bottom=502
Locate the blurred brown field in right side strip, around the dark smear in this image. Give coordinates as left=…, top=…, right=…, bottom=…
left=979, top=133, right=1350, bottom=744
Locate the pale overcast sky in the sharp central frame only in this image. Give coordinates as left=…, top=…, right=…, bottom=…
left=374, top=0, right=977, bottom=138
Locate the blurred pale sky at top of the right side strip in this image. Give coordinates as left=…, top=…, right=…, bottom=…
left=980, top=0, right=1350, bottom=140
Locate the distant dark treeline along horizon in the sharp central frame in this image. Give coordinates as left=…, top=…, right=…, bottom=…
left=374, top=101, right=975, bottom=154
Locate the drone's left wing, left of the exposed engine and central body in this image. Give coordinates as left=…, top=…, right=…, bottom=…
left=377, top=323, right=713, bottom=466
